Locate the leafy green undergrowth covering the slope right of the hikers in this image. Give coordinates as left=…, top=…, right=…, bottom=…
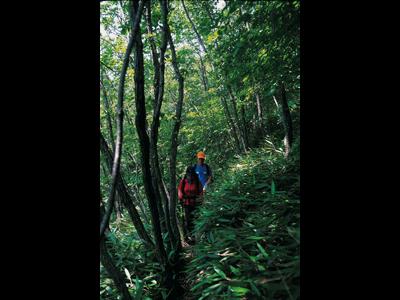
left=186, top=144, right=300, bottom=300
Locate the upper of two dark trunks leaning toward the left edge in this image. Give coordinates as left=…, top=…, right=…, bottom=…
left=100, top=132, right=154, bottom=247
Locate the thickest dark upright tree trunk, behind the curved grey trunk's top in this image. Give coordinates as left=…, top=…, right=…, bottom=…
left=133, top=2, right=167, bottom=266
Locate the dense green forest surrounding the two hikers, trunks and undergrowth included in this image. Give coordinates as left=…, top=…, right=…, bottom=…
left=99, top=0, right=300, bottom=300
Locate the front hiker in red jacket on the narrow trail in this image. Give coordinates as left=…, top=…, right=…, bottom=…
left=178, top=167, right=203, bottom=241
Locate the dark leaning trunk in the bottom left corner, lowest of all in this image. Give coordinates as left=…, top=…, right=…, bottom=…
left=100, top=200, right=132, bottom=300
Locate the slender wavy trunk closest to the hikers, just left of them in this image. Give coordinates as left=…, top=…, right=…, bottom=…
left=167, top=28, right=184, bottom=247
